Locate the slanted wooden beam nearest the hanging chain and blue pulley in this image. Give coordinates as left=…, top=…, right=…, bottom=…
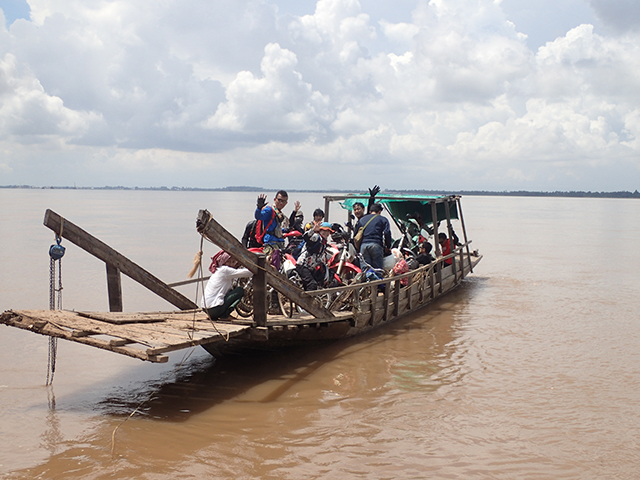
left=44, top=209, right=198, bottom=310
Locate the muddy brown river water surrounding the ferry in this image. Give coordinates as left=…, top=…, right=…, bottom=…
left=0, top=189, right=640, bottom=480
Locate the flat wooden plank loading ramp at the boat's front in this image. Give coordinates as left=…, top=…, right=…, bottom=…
left=0, top=310, right=251, bottom=363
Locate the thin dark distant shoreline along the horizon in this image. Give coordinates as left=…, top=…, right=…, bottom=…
left=0, top=185, right=640, bottom=198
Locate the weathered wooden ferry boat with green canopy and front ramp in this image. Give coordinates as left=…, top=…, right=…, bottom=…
left=0, top=195, right=482, bottom=362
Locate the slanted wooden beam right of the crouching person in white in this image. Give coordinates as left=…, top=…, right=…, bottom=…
left=196, top=210, right=333, bottom=318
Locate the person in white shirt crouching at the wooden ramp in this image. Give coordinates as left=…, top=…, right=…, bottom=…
left=202, top=250, right=252, bottom=320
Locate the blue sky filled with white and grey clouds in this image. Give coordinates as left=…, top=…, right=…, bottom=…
left=0, top=0, right=640, bottom=191
